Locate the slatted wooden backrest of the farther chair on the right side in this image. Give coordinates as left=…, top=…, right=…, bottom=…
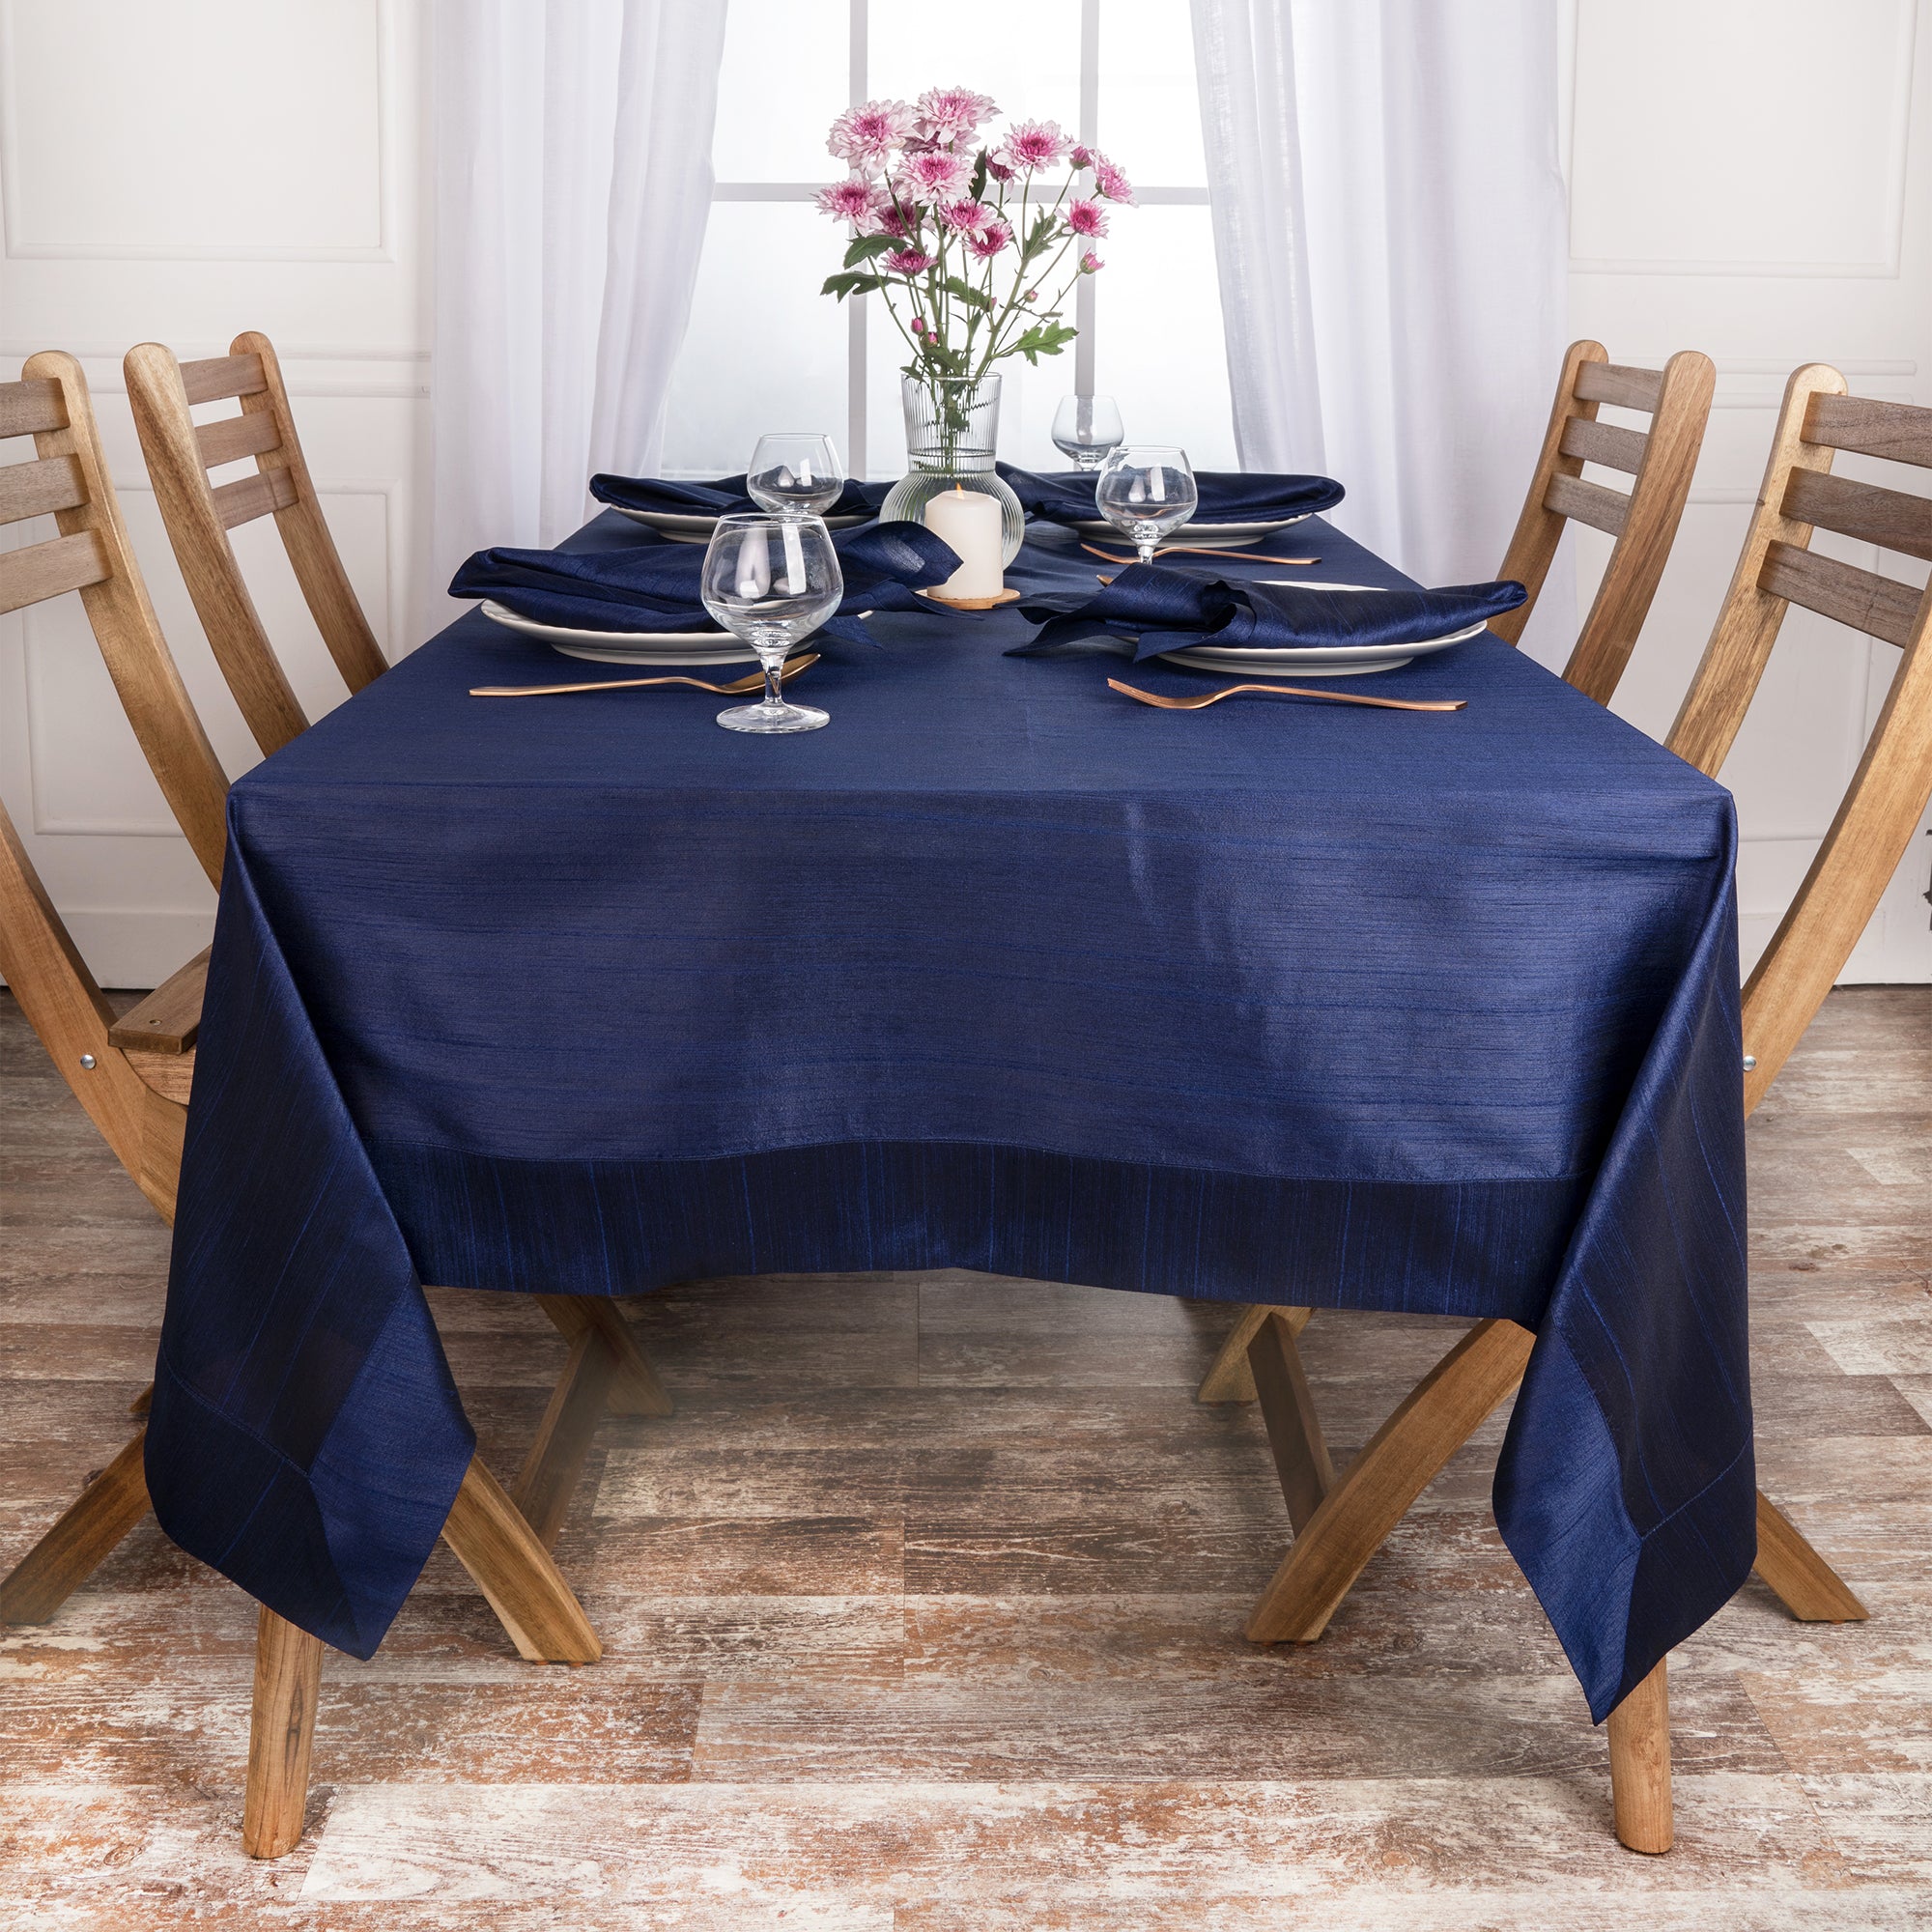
left=1490, top=342, right=1716, bottom=703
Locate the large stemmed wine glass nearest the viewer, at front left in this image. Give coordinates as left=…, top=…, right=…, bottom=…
left=699, top=510, right=844, bottom=732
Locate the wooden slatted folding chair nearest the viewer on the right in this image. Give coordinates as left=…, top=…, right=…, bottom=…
left=1206, top=363, right=1932, bottom=1851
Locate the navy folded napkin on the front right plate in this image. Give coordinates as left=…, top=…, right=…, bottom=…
left=1007, top=564, right=1528, bottom=663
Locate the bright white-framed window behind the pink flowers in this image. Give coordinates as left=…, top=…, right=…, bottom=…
left=665, top=0, right=1236, bottom=477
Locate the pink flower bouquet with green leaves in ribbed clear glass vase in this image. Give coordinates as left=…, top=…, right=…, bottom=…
left=817, top=87, right=1134, bottom=562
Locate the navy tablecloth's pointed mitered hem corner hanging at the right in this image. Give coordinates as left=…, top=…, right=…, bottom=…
left=1495, top=1327, right=1758, bottom=1723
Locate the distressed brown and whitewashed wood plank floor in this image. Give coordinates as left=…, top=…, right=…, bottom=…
left=0, top=989, right=1932, bottom=1932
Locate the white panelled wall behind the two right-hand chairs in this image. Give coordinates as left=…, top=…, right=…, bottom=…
left=1569, top=0, right=1932, bottom=981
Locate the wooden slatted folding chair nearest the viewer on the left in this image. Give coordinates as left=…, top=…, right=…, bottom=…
left=0, top=352, right=649, bottom=1857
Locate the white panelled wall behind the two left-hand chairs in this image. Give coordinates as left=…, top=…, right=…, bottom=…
left=0, top=0, right=429, bottom=985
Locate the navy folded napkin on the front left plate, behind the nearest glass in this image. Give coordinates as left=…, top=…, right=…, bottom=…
left=450, top=524, right=960, bottom=643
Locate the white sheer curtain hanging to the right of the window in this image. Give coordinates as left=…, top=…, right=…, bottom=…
left=1194, top=0, right=1567, bottom=618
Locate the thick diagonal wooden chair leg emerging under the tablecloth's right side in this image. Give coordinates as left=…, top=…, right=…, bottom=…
left=1248, top=1320, right=1536, bottom=1644
